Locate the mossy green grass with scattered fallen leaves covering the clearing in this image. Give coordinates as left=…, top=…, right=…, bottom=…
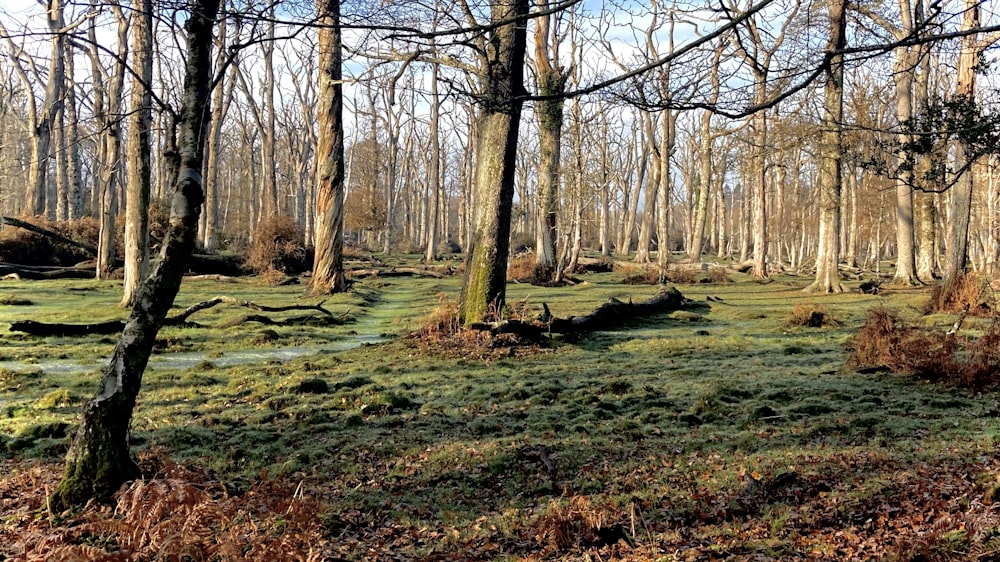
left=0, top=266, right=1000, bottom=560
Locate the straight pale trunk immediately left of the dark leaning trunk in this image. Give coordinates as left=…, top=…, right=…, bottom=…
left=121, top=0, right=153, bottom=307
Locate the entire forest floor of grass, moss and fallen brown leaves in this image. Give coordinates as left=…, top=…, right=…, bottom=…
left=0, top=256, right=1000, bottom=561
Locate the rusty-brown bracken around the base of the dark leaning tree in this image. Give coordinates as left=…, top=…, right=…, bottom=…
left=0, top=453, right=330, bottom=562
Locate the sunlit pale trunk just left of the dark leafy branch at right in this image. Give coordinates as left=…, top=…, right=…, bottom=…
left=805, top=0, right=847, bottom=293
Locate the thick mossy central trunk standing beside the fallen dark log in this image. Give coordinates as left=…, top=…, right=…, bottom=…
left=459, top=0, right=528, bottom=325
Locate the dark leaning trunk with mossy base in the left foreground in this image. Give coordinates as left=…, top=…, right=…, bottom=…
left=50, top=0, right=218, bottom=512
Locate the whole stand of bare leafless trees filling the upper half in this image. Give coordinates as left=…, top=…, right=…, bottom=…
left=0, top=0, right=1000, bottom=503
